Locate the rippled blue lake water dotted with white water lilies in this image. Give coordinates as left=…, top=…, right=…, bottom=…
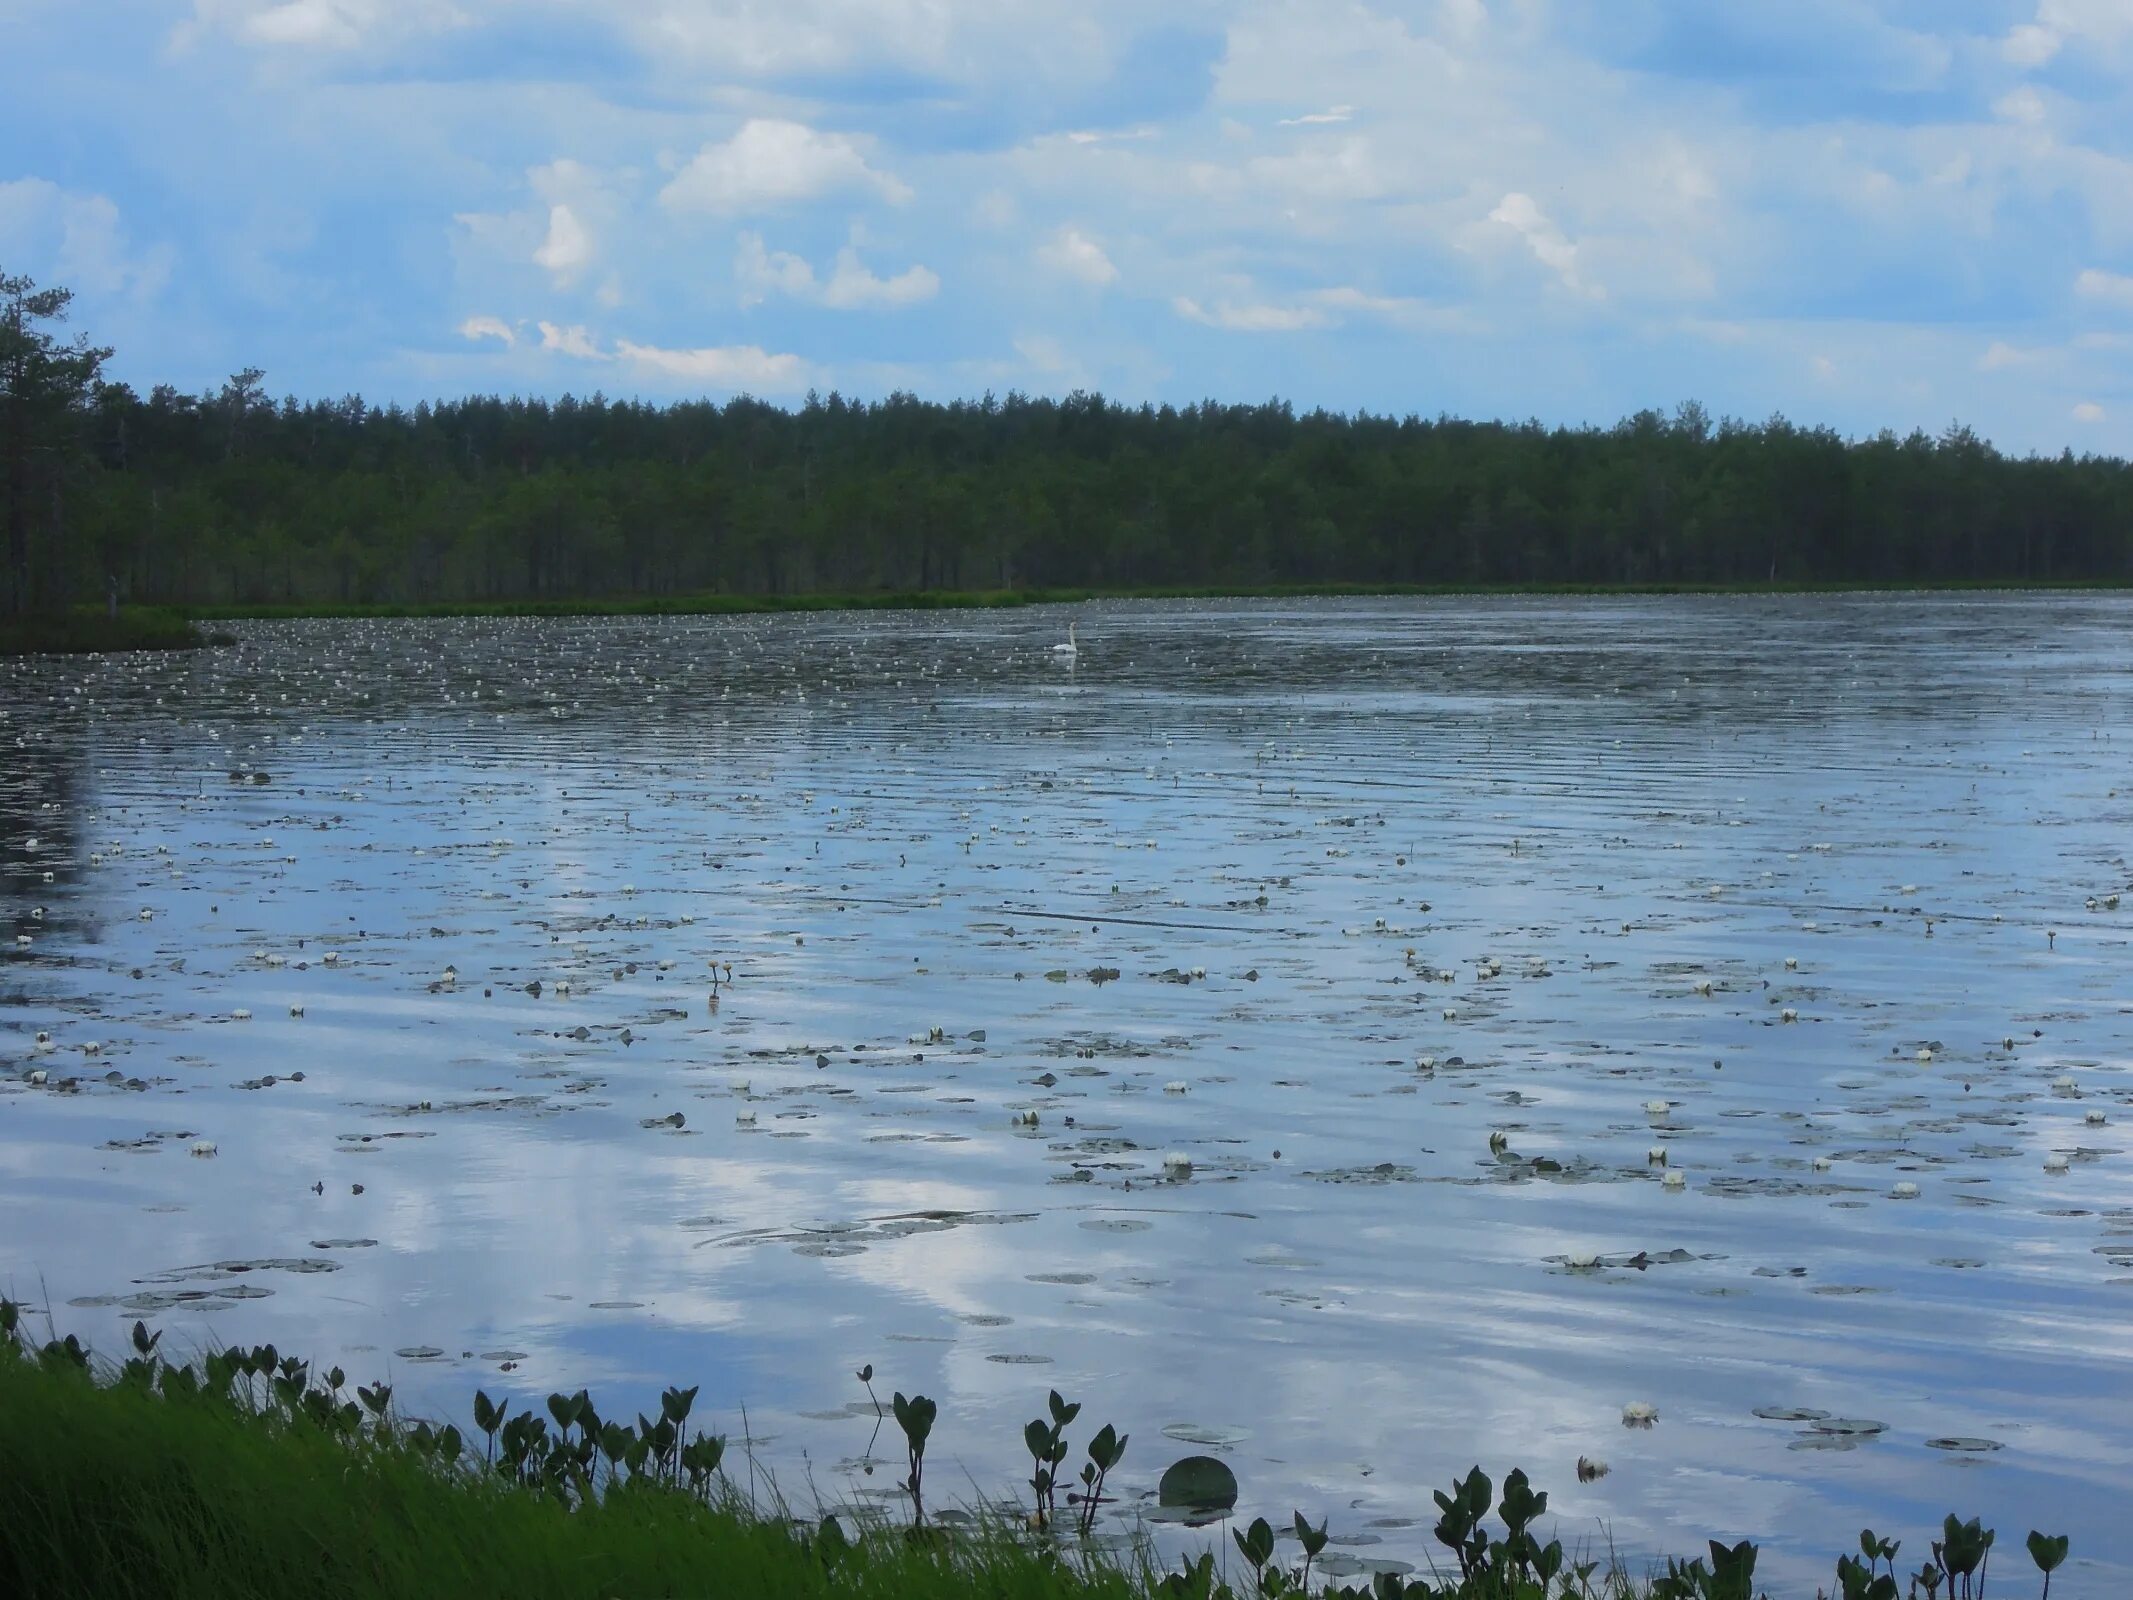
left=0, top=595, right=2133, bottom=1596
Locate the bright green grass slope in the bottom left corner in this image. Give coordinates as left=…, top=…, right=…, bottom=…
left=0, top=1357, right=1137, bottom=1600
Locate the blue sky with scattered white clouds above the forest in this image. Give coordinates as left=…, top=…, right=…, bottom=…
left=0, top=0, right=2133, bottom=454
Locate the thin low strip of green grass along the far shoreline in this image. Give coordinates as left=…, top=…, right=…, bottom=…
left=186, top=580, right=2129, bottom=619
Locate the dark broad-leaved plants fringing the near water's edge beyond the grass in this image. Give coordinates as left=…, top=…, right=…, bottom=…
left=0, top=1299, right=2069, bottom=1600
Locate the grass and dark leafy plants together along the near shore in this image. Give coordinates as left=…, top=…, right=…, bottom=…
left=0, top=1299, right=2067, bottom=1600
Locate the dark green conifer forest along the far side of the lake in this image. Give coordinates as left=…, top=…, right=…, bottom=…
left=0, top=273, right=2133, bottom=614
